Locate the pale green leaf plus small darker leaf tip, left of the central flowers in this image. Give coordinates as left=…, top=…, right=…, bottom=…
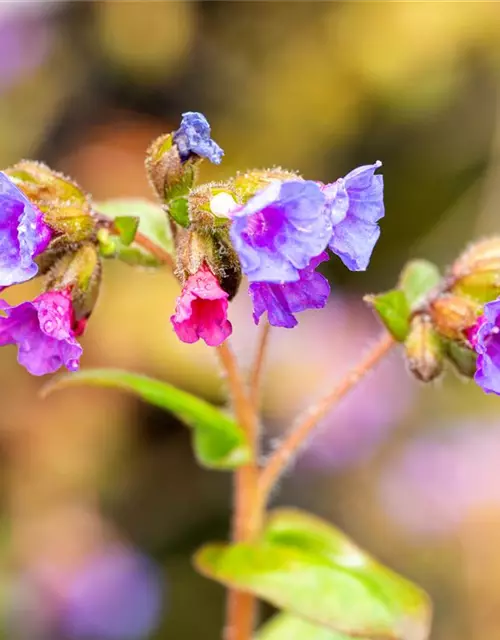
left=95, top=198, right=174, bottom=267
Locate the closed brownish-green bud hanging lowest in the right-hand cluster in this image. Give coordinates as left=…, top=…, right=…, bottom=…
left=405, top=314, right=443, bottom=382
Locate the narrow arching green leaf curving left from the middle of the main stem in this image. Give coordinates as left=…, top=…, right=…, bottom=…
left=42, top=369, right=250, bottom=469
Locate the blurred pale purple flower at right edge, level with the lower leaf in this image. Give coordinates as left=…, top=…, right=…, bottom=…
left=379, top=423, right=500, bottom=536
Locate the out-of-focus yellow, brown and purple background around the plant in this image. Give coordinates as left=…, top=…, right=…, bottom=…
left=0, top=0, right=500, bottom=640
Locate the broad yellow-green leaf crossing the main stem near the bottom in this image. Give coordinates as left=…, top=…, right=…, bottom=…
left=195, top=510, right=430, bottom=640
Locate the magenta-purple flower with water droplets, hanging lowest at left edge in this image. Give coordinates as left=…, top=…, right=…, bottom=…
left=0, top=291, right=82, bottom=376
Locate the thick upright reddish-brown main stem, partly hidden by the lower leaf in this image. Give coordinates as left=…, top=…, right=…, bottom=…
left=217, top=341, right=263, bottom=640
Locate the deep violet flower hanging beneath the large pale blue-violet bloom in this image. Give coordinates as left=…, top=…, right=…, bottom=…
left=249, top=252, right=330, bottom=329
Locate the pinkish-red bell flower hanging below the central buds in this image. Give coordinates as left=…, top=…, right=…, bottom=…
left=170, top=263, right=233, bottom=347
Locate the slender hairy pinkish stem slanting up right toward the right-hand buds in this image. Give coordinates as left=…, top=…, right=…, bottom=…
left=259, top=334, right=395, bottom=509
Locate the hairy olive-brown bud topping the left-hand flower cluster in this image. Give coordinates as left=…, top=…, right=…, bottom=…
left=5, top=160, right=96, bottom=243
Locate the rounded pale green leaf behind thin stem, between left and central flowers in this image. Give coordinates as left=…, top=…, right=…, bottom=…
left=95, top=198, right=174, bottom=266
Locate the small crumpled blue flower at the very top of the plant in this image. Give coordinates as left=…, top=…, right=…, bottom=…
left=174, top=111, right=224, bottom=164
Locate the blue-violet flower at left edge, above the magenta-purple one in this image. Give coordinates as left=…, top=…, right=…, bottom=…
left=0, top=173, right=51, bottom=287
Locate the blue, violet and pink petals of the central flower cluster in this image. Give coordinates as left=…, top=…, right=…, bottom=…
left=172, top=113, right=384, bottom=346
